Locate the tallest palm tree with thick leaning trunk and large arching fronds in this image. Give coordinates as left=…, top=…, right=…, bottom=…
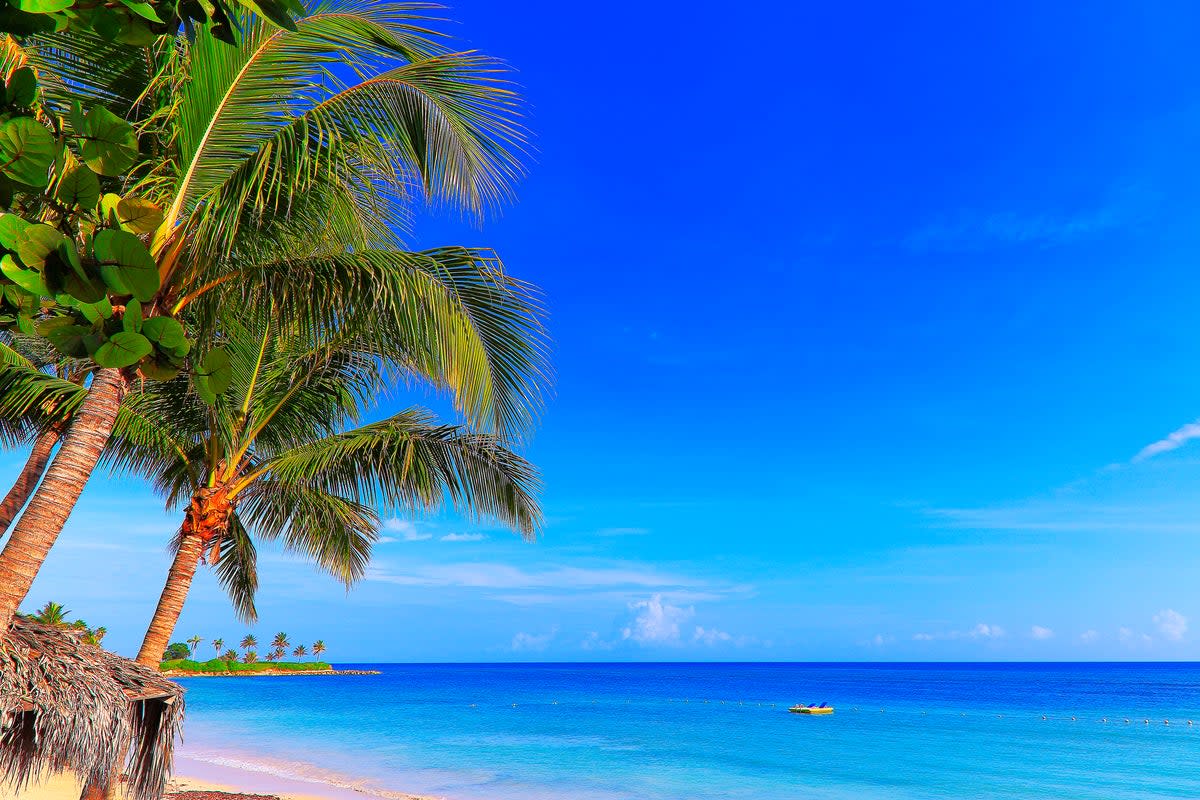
left=0, top=0, right=545, bottom=628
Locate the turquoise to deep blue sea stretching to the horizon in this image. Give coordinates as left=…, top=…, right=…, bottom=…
left=175, top=664, right=1200, bottom=800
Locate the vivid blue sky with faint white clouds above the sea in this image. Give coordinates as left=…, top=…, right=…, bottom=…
left=7, top=0, right=1200, bottom=661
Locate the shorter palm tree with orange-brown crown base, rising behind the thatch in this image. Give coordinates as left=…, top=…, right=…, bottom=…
left=115, top=309, right=540, bottom=658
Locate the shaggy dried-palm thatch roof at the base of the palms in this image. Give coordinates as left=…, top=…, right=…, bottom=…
left=0, top=619, right=184, bottom=800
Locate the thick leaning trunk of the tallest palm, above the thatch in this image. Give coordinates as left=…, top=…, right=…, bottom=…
left=0, top=369, right=126, bottom=634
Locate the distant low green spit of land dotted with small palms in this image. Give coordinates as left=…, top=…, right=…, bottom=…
left=158, top=632, right=379, bottom=678
